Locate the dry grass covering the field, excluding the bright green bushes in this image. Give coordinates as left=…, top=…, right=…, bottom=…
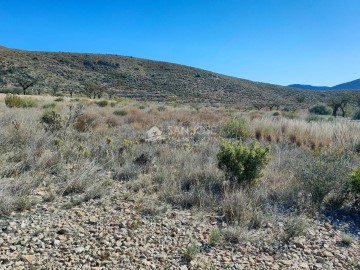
left=0, top=93, right=360, bottom=247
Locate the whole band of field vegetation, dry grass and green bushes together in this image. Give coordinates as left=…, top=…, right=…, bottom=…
left=0, top=92, right=360, bottom=265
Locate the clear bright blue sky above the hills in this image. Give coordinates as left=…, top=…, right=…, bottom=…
left=0, top=0, right=360, bottom=86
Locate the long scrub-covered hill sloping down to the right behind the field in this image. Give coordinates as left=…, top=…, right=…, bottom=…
left=0, top=47, right=358, bottom=106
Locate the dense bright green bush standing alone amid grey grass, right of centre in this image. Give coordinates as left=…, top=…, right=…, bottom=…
left=217, top=141, right=270, bottom=185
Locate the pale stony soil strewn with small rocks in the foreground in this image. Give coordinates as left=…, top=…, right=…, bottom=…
left=0, top=182, right=360, bottom=269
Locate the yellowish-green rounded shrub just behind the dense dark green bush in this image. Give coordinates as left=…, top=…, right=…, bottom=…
left=219, top=118, right=252, bottom=139
